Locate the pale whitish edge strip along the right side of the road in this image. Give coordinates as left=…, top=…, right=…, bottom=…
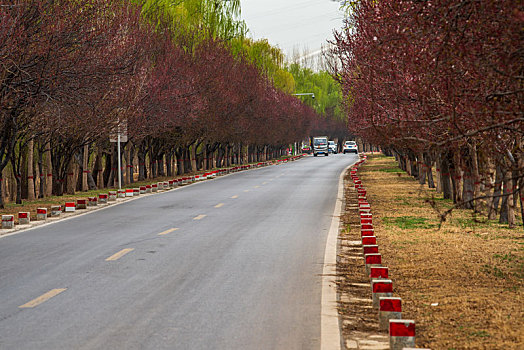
left=320, top=163, right=354, bottom=350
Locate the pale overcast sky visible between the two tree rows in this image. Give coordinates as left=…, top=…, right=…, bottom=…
left=241, top=0, right=343, bottom=58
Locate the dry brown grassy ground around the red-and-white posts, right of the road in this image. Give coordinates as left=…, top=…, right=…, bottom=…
left=338, top=155, right=524, bottom=349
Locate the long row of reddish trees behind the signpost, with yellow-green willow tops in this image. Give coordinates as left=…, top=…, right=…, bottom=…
left=0, top=0, right=348, bottom=207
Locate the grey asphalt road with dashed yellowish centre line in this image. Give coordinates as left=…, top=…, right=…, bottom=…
left=0, top=154, right=356, bottom=350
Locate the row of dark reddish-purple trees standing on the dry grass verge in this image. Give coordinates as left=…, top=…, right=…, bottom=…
left=332, top=0, right=524, bottom=226
